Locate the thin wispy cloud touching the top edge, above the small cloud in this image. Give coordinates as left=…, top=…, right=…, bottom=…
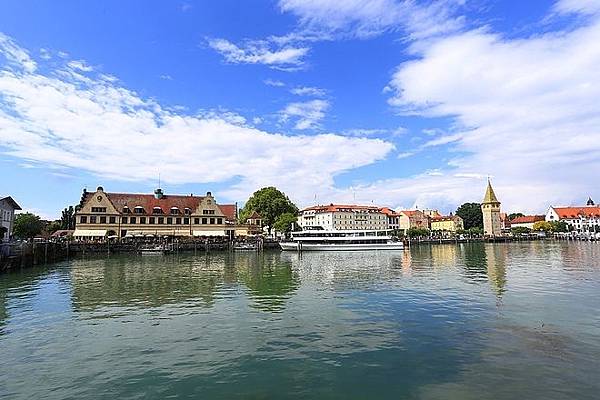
left=279, top=0, right=463, bottom=39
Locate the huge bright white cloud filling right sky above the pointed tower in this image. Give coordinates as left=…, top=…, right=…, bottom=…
left=374, top=0, right=600, bottom=212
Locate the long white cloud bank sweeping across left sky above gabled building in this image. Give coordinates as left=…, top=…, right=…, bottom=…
left=0, top=34, right=394, bottom=204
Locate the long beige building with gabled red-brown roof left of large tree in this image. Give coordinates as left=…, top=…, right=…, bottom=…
left=73, top=187, right=237, bottom=239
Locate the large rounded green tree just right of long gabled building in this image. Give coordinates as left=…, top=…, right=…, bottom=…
left=240, top=186, right=298, bottom=233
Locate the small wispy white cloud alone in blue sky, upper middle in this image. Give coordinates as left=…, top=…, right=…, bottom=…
left=208, top=39, right=309, bottom=70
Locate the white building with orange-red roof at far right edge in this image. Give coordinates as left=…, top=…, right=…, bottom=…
left=545, top=198, right=600, bottom=233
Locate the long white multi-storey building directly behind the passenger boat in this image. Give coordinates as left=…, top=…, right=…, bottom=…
left=298, top=204, right=388, bottom=230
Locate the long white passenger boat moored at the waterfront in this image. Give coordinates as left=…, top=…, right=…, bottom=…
left=279, top=230, right=404, bottom=251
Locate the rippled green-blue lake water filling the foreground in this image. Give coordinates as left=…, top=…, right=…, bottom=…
left=0, top=242, right=600, bottom=399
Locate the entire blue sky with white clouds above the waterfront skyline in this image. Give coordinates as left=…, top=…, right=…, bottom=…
left=0, top=0, right=600, bottom=219
